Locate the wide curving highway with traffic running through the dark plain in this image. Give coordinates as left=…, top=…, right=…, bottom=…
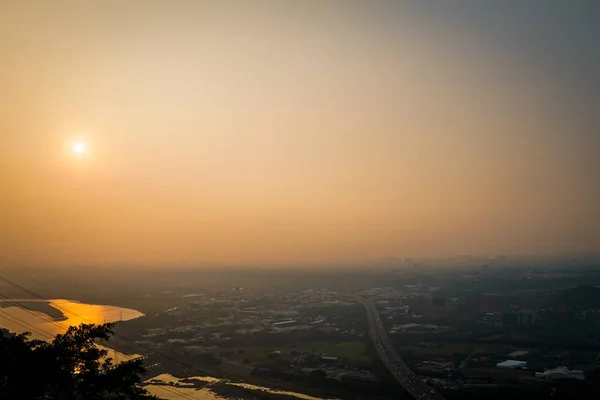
left=358, top=298, right=445, bottom=400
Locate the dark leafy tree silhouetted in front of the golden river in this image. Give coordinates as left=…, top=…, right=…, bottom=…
left=0, top=324, right=157, bottom=400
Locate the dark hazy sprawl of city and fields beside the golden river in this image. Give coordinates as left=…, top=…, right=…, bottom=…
left=5, top=256, right=600, bottom=399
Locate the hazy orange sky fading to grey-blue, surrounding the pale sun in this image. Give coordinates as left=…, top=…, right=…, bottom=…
left=0, top=0, right=600, bottom=265
